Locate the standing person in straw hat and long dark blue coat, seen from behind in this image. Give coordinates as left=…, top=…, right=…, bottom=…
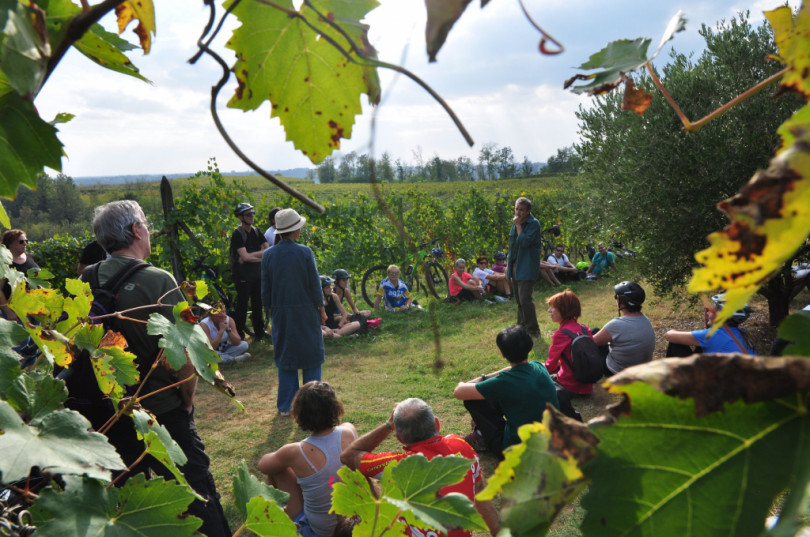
left=262, top=209, right=326, bottom=416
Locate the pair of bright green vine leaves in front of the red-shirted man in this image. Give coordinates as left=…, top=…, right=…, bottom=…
left=332, top=454, right=485, bottom=536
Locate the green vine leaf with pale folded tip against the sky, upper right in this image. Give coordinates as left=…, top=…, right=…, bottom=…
left=563, top=11, right=686, bottom=95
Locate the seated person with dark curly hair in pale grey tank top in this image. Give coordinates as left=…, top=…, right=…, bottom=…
left=259, top=380, right=357, bottom=537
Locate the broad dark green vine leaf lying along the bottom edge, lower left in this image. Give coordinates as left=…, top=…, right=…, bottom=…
left=33, top=474, right=202, bottom=537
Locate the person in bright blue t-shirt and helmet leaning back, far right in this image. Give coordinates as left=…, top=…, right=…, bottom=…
left=664, top=294, right=757, bottom=357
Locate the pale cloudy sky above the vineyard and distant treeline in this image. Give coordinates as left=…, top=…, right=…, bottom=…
left=35, top=0, right=799, bottom=177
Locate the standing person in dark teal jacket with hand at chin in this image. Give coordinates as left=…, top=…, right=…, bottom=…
left=506, top=197, right=543, bottom=337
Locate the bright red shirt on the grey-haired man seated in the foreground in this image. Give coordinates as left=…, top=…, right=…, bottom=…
left=359, top=434, right=481, bottom=537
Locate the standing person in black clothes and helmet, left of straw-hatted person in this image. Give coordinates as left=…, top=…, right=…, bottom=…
left=230, top=203, right=268, bottom=341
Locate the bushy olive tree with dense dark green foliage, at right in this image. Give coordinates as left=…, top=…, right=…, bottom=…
left=576, top=11, right=799, bottom=306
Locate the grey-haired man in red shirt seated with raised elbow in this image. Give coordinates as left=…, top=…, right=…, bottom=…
left=340, top=398, right=499, bottom=537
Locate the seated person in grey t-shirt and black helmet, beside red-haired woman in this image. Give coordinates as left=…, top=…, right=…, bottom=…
left=593, top=281, right=655, bottom=376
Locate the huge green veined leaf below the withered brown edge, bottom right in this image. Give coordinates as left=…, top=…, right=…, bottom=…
left=581, top=382, right=810, bottom=537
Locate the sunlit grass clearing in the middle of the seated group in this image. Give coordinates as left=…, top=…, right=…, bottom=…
left=189, top=279, right=784, bottom=536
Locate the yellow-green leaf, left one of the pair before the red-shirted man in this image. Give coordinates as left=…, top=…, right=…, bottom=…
left=332, top=463, right=407, bottom=537
